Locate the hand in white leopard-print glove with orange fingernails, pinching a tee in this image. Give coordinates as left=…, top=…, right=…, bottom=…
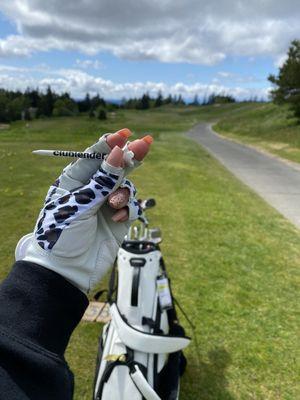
left=20, top=129, right=152, bottom=292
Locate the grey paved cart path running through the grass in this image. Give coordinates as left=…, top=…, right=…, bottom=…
left=188, top=124, right=300, bottom=228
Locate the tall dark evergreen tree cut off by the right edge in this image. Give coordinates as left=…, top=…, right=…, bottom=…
left=268, top=40, right=300, bottom=122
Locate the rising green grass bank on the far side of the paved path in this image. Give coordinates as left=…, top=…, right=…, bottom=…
left=214, top=103, right=300, bottom=162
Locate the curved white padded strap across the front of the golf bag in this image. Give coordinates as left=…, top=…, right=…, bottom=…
left=110, top=303, right=190, bottom=354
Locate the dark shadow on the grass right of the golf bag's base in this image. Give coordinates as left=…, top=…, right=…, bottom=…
left=181, top=348, right=235, bottom=400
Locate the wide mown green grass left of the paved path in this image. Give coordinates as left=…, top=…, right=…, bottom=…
left=0, top=104, right=300, bottom=400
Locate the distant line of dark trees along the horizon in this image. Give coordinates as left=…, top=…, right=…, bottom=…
left=0, top=86, right=239, bottom=123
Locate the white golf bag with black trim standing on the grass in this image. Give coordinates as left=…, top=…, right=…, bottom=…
left=94, top=241, right=190, bottom=400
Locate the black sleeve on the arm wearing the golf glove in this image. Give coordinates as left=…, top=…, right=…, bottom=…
left=0, top=261, right=88, bottom=400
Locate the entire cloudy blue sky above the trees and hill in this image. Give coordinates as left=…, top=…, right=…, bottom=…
left=0, top=0, right=300, bottom=100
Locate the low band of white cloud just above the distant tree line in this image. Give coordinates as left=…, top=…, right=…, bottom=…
left=0, top=65, right=269, bottom=100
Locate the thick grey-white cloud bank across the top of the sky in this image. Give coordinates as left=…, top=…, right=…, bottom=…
left=0, top=0, right=300, bottom=65
